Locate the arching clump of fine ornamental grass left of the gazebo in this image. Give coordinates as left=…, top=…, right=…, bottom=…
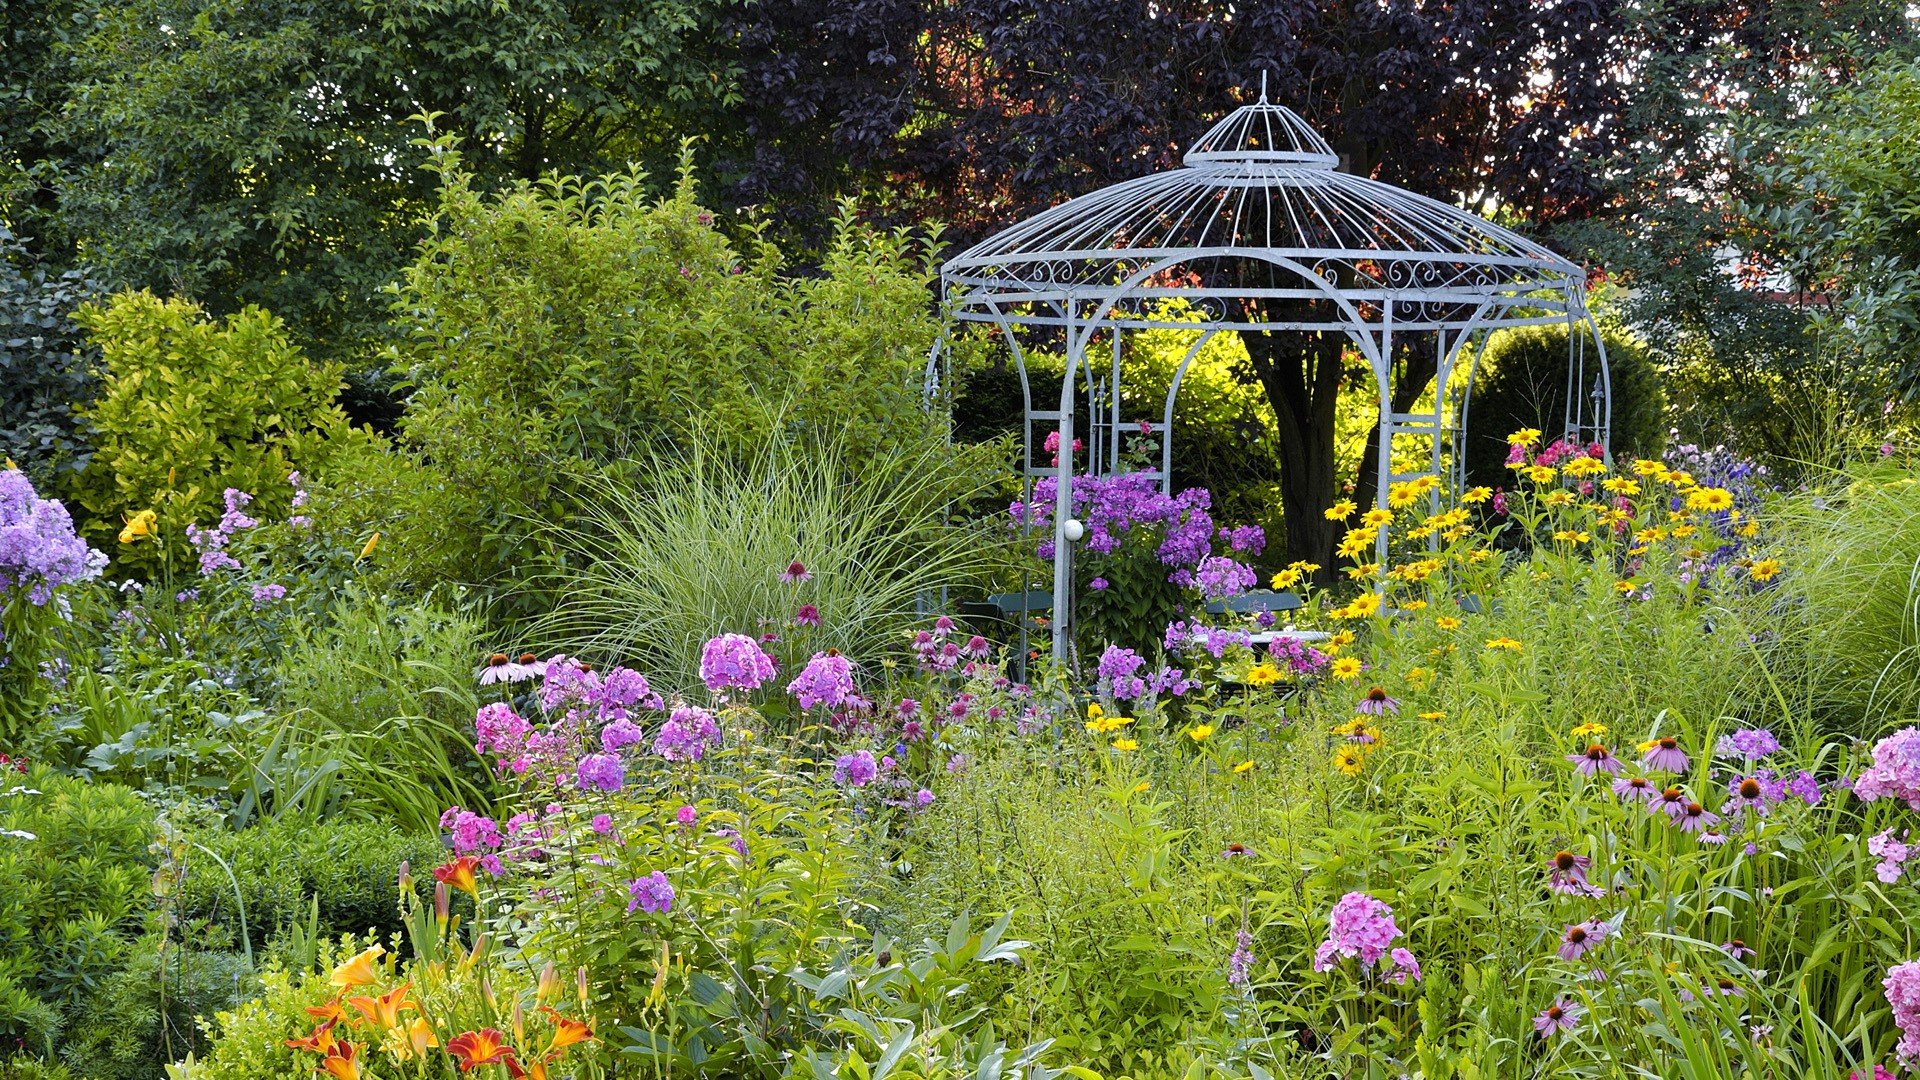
left=534, top=426, right=1008, bottom=688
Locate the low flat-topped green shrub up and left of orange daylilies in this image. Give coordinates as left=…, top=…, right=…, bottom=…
left=175, top=819, right=442, bottom=949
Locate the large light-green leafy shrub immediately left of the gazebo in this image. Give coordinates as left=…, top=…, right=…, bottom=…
left=394, top=155, right=956, bottom=580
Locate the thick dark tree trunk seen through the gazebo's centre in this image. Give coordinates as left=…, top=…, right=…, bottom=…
left=1240, top=331, right=1346, bottom=582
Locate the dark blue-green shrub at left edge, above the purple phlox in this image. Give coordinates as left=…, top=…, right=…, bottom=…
left=0, top=225, right=102, bottom=484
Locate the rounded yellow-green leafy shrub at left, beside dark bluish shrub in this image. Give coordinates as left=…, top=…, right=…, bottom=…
left=69, top=292, right=372, bottom=575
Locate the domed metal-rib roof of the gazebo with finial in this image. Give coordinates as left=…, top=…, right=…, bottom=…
left=941, top=100, right=1586, bottom=321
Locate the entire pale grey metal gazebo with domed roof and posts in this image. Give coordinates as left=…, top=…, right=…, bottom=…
left=927, top=92, right=1611, bottom=659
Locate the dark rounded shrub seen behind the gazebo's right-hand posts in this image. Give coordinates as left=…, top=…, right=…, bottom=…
left=1463, top=325, right=1667, bottom=486
